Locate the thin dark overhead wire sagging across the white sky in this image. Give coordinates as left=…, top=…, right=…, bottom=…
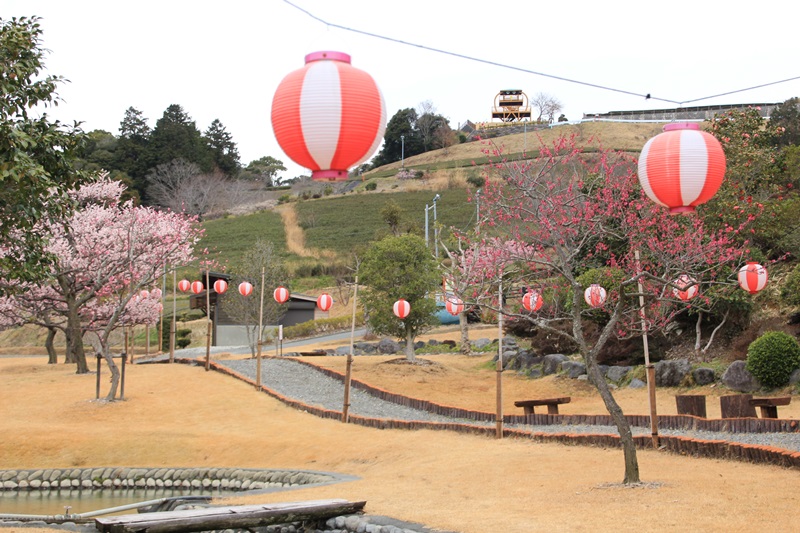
left=283, top=0, right=800, bottom=106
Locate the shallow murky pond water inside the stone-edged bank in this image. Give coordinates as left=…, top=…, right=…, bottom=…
left=0, top=488, right=233, bottom=515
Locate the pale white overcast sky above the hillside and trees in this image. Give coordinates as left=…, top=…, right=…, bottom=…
left=6, top=0, right=800, bottom=178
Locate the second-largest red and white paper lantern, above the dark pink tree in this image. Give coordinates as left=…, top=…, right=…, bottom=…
left=639, top=122, right=725, bottom=214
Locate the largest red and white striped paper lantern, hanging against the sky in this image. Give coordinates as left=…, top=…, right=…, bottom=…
left=272, top=52, right=386, bottom=181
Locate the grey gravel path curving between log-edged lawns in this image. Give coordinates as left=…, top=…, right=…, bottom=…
left=147, top=349, right=800, bottom=452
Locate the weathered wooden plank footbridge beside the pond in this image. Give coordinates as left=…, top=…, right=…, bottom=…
left=95, top=499, right=367, bottom=533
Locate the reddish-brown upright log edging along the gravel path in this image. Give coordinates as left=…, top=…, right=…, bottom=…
left=189, top=359, right=800, bottom=468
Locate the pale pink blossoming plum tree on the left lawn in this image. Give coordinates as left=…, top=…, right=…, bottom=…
left=0, top=174, right=202, bottom=392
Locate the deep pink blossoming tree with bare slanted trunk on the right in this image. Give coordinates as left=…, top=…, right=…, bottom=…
left=463, top=138, right=749, bottom=483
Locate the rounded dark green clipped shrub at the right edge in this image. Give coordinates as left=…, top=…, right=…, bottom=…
left=745, top=331, right=800, bottom=389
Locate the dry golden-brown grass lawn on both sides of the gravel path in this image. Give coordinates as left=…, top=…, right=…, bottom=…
left=0, top=324, right=798, bottom=533
